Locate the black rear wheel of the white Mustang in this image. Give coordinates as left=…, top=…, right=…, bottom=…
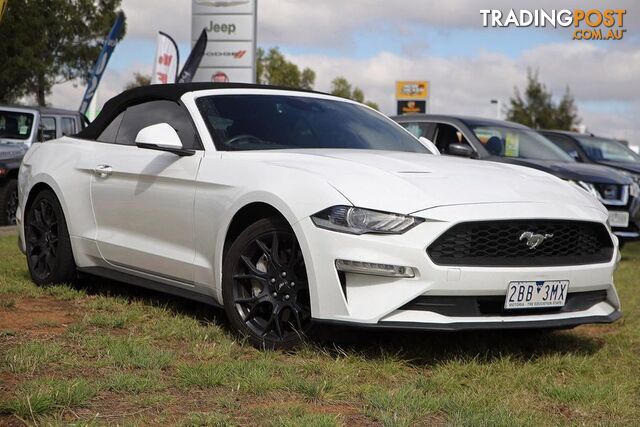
left=24, top=190, right=76, bottom=286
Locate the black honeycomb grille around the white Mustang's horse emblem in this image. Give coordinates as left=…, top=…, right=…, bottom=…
left=427, top=220, right=613, bottom=267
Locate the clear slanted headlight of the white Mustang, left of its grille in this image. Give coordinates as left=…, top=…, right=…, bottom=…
left=311, top=206, right=424, bottom=234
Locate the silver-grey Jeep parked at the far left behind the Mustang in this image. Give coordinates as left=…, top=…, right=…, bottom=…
left=0, top=106, right=83, bottom=225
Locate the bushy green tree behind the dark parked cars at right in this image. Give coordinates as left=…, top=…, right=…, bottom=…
left=507, top=70, right=580, bottom=130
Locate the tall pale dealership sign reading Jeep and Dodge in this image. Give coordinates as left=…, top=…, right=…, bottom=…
left=191, top=0, right=257, bottom=83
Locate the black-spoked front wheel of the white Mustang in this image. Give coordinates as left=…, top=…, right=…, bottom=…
left=222, top=217, right=311, bottom=349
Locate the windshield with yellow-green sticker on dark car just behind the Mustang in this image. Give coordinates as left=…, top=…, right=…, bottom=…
left=470, top=125, right=575, bottom=162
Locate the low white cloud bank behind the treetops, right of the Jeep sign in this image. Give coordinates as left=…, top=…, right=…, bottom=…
left=292, top=43, right=640, bottom=141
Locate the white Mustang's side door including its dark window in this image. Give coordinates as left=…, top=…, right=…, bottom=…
left=91, top=100, right=203, bottom=286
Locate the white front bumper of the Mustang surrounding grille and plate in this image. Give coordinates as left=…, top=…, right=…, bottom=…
left=294, top=203, right=620, bottom=330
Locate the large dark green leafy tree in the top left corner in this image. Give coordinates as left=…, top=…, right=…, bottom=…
left=0, top=0, right=124, bottom=105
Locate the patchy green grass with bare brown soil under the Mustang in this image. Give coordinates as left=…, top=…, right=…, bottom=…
left=0, top=237, right=640, bottom=427
